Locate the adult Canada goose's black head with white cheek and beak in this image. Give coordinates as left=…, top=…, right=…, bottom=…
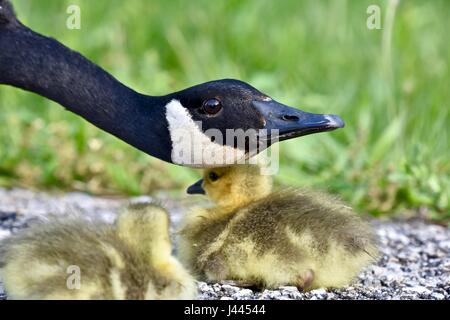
left=163, top=79, right=344, bottom=167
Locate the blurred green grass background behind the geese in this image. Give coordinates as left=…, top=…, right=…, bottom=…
left=0, top=0, right=450, bottom=221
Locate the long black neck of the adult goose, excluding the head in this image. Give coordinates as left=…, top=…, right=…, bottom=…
left=0, top=0, right=170, bottom=161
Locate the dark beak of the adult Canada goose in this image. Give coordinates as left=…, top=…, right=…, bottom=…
left=253, top=100, right=345, bottom=141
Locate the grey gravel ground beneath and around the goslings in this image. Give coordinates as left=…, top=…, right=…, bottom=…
left=0, top=189, right=450, bottom=300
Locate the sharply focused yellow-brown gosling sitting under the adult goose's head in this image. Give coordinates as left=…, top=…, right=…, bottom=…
left=179, top=165, right=377, bottom=289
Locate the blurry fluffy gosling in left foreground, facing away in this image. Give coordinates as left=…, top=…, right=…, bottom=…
left=0, top=204, right=197, bottom=299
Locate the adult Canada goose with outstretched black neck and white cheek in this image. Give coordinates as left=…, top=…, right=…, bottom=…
left=0, top=0, right=344, bottom=167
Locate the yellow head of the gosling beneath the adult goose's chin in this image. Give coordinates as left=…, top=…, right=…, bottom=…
left=187, top=164, right=272, bottom=208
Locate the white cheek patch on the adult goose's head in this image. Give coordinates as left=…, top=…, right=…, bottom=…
left=166, top=100, right=246, bottom=167
